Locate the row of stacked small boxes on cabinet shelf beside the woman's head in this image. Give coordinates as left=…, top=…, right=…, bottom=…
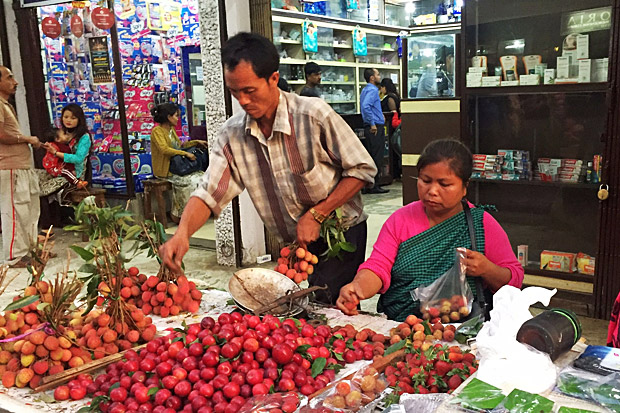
left=472, top=149, right=532, bottom=181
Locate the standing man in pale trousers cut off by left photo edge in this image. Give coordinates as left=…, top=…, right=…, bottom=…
left=0, top=66, right=41, bottom=268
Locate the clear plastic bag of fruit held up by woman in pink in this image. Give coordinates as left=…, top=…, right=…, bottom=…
left=411, top=248, right=474, bottom=324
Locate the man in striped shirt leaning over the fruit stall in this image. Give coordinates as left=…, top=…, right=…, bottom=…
left=161, top=33, right=377, bottom=303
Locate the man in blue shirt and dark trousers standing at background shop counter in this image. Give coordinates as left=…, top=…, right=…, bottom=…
left=360, top=68, right=390, bottom=194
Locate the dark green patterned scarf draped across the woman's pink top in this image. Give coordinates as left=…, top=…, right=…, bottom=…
left=377, top=208, right=485, bottom=321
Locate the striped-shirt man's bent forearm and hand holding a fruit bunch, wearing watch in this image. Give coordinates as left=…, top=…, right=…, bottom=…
left=297, top=177, right=366, bottom=247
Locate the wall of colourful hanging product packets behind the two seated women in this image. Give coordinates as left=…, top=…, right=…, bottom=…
left=38, top=0, right=200, bottom=192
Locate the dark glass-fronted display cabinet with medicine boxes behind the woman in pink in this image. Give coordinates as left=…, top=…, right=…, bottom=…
left=462, top=0, right=617, bottom=315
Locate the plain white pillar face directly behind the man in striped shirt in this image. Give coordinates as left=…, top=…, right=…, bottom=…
left=226, top=0, right=265, bottom=265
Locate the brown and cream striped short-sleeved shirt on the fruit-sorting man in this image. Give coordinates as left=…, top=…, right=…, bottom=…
left=192, top=91, right=377, bottom=242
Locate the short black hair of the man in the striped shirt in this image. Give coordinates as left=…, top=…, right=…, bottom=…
left=222, top=32, right=280, bottom=80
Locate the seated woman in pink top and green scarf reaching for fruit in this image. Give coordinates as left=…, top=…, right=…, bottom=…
left=337, top=139, right=523, bottom=321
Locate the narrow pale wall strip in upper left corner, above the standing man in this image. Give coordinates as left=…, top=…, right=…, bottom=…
left=2, top=0, right=30, bottom=135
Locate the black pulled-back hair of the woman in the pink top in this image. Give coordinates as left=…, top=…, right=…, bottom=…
left=418, top=139, right=473, bottom=184
